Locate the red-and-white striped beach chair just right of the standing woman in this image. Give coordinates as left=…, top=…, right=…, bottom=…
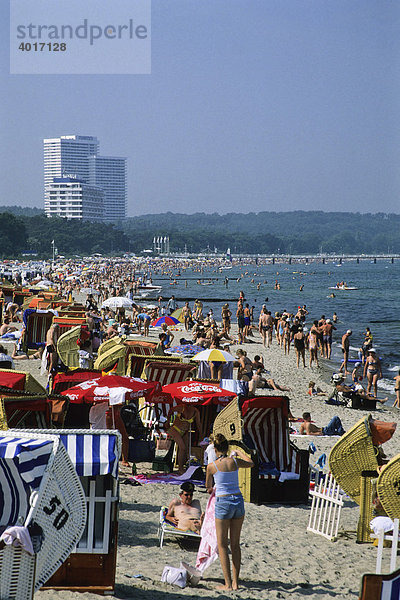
left=242, top=396, right=309, bottom=504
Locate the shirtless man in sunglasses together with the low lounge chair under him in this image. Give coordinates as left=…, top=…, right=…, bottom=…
left=159, top=481, right=204, bottom=548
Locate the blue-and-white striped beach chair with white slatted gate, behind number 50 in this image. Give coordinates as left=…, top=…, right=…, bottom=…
left=33, top=429, right=121, bottom=594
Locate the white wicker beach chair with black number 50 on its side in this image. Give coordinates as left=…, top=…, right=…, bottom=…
left=0, top=430, right=86, bottom=600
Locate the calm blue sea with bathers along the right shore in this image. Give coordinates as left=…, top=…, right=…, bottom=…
left=153, top=259, right=400, bottom=398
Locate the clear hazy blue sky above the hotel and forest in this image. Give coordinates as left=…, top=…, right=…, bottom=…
left=0, top=0, right=400, bottom=215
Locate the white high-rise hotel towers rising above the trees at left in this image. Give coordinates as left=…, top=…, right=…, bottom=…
left=44, top=135, right=127, bottom=221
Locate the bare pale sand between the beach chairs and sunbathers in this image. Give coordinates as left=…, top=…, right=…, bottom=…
left=3, top=318, right=400, bottom=600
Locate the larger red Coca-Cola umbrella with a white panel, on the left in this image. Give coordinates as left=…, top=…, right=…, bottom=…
left=61, top=375, right=161, bottom=406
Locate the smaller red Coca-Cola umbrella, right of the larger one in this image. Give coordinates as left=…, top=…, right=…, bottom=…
left=159, top=381, right=237, bottom=404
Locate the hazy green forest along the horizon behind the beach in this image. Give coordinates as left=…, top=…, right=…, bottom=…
left=0, top=206, right=400, bottom=258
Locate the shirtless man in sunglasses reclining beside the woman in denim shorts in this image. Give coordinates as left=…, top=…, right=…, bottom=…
left=165, top=481, right=204, bottom=532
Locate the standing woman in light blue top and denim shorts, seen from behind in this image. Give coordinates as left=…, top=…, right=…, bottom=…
left=206, top=433, right=254, bottom=590
